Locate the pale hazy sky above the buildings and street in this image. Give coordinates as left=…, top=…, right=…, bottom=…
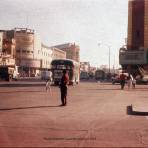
left=0, top=0, right=128, bottom=67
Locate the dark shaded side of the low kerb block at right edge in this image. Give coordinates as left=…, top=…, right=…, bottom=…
left=126, top=105, right=148, bottom=116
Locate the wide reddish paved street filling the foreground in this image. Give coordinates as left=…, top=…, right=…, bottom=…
left=0, top=81, right=148, bottom=147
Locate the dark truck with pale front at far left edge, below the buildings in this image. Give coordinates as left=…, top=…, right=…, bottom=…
left=0, top=65, right=19, bottom=81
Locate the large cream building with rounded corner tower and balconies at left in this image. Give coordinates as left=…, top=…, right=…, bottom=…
left=0, top=28, right=52, bottom=76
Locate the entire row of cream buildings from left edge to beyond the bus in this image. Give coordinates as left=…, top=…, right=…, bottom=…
left=0, top=28, right=72, bottom=77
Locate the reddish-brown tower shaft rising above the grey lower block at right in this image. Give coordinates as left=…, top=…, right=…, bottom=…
left=127, top=0, right=145, bottom=50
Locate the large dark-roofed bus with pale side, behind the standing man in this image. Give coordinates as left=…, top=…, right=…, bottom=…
left=51, top=59, right=80, bottom=85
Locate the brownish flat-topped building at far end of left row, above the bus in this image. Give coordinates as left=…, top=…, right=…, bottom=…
left=54, top=43, right=80, bottom=62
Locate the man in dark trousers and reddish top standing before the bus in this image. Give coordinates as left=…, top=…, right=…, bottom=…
left=60, top=70, right=69, bottom=106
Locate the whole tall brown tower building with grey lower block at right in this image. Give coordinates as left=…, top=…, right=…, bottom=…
left=119, top=0, right=148, bottom=73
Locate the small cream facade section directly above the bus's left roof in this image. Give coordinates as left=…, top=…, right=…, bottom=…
left=52, top=47, right=66, bottom=59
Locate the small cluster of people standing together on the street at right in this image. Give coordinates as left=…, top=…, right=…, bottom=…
left=120, top=72, right=136, bottom=89
